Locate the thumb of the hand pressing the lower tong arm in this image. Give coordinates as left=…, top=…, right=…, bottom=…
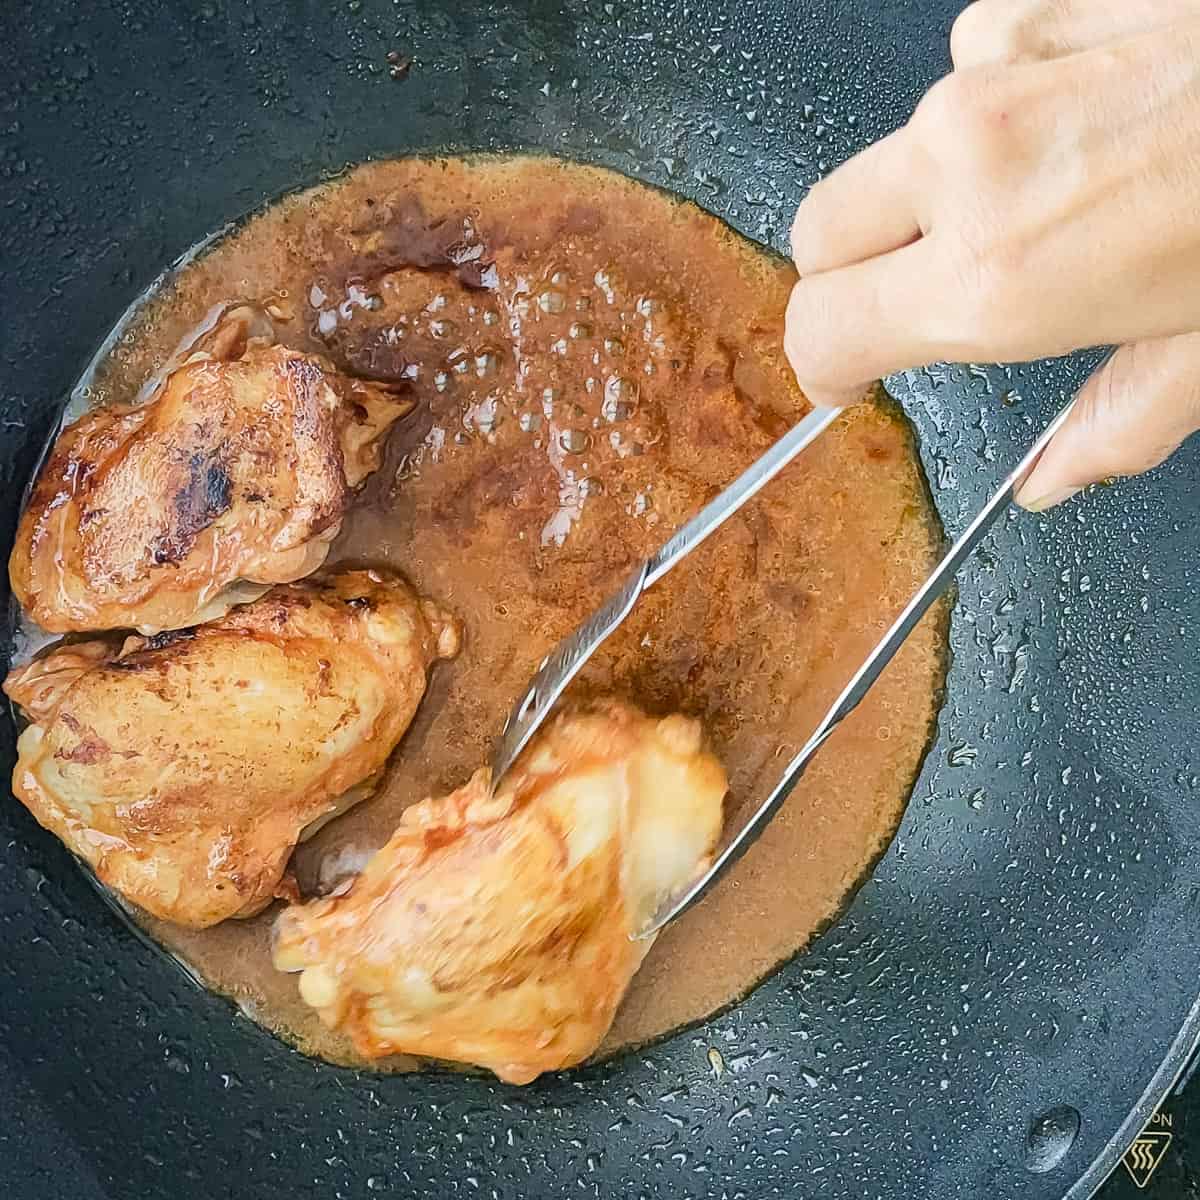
left=1016, top=334, right=1200, bottom=512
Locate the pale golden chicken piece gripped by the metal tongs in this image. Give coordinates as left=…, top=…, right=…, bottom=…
left=275, top=703, right=726, bottom=1084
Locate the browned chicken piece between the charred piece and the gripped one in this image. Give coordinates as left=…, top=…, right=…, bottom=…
left=4, top=571, right=460, bottom=928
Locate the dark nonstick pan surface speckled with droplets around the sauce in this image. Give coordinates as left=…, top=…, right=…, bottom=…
left=0, top=0, right=1200, bottom=1200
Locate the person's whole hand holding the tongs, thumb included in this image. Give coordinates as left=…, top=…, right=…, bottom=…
left=786, top=0, right=1200, bottom=509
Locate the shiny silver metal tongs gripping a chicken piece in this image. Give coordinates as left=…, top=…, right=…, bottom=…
left=492, top=400, right=1075, bottom=938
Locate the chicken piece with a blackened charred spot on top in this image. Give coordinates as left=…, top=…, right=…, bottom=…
left=10, top=310, right=413, bottom=634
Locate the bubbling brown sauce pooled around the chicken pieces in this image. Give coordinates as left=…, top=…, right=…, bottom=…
left=28, top=157, right=946, bottom=1069
